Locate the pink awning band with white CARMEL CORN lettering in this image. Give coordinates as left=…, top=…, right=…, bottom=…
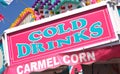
left=4, top=45, right=120, bottom=74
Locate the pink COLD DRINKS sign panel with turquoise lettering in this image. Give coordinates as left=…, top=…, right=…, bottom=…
left=3, top=6, right=117, bottom=65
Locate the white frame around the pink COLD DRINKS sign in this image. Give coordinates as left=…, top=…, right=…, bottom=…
left=2, top=1, right=119, bottom=66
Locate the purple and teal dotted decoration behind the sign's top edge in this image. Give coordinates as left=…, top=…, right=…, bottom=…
left=32, top=0, right=86, bottom=20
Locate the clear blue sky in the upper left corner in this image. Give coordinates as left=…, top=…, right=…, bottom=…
left=0, top=0, right=36, bottom=35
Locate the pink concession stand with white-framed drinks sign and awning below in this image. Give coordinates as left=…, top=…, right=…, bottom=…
left=2, top=1, right=120, bottom=74
